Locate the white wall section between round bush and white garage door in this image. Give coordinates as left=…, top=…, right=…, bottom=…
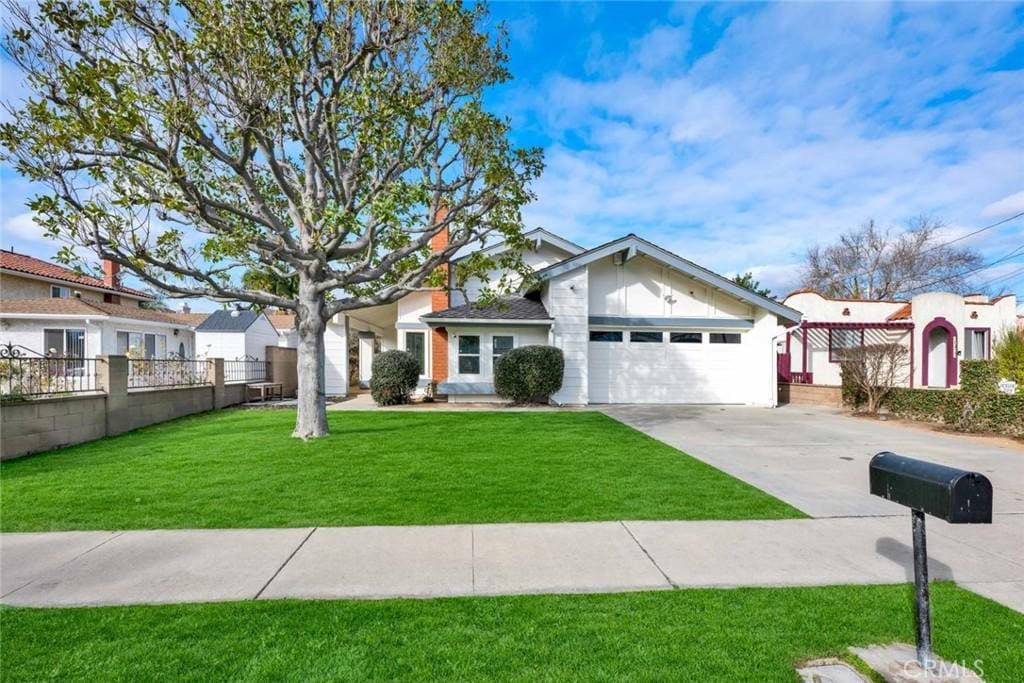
left=543, top=267, right=590, bottom=404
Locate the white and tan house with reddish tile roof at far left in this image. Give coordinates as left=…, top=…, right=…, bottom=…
left=0, top=251, right=195, bottom=358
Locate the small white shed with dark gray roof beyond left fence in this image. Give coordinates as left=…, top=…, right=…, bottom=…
left=196, top=308, right=281, bottom=360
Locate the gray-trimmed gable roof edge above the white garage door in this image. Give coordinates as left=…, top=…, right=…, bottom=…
left=537, top=233, right=802, bottom=323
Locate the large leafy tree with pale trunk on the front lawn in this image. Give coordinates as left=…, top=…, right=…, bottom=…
left=0, top=0, right=542, bottom=437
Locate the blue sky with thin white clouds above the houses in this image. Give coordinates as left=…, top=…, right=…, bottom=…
left=0, top=2, right=1024, bottom=305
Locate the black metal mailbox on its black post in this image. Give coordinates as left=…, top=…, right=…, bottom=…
left=868, top=453, right=992, bottom=670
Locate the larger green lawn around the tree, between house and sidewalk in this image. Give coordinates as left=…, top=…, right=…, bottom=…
left=0, top=410, right=803, bottom=531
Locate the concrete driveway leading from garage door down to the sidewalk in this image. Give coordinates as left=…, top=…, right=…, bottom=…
left=602, top=405, right=1024, bottom=518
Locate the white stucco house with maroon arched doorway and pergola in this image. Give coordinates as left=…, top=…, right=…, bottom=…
left=779, top=290, right=1017, bottom=388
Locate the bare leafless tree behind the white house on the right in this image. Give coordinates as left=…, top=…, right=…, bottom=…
left=801, top=217, right=983, bottom=299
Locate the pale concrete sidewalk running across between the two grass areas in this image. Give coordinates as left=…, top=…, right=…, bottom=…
left=0, top=514, right=1024, bottom=611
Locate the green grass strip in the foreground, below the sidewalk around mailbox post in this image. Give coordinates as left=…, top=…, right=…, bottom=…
left=0, top=584, right=1024, bottom=683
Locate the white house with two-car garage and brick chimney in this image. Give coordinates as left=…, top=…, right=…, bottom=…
left=325, top=230, right=800, bottom=405
